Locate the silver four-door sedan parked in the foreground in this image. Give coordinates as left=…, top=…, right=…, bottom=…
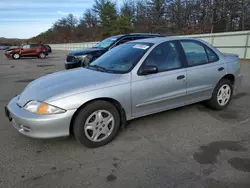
left=5, top=37, right=242, bottom=147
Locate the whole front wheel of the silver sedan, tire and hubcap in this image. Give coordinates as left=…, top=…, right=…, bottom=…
left=73, top=101, right=120, bottom=148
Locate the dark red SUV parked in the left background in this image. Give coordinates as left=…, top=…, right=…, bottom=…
left=4, top=44, right=48, bottom=59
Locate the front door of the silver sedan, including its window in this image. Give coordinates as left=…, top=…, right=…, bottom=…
left=131, top=41, right=186, bottom=117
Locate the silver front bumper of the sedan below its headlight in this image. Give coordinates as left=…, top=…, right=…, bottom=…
left=5, top=97, right=76, bottom=138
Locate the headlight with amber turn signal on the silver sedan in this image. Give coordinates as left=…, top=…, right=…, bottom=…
left=23, top=101, right=66, bottom=115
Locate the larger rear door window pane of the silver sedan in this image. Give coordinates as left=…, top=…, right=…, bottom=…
left=181, top=41, right=209, bottom=66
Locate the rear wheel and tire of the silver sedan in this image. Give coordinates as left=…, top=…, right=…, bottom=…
left=206, top=79, right=234, bottom=110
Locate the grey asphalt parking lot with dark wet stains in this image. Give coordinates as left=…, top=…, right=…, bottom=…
left=0, top=51, right=250, bottom=188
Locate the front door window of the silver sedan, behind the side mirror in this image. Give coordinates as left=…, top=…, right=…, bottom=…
left=142, top=42, right=182, bottom=72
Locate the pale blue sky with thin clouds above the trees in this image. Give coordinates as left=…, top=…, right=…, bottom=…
left=0, top=0, right=123, bottom=38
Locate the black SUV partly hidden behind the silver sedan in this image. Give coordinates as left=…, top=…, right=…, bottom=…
left=65, top=33, right=164, bottom=69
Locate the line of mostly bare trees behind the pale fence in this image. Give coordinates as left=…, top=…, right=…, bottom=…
left=31, top=0, right=250, bottom=43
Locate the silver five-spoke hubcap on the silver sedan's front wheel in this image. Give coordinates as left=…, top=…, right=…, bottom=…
left=84, top=110, right=115, bottom=142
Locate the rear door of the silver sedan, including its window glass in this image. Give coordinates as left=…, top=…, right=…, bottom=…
left=180, top=40, right=226, bottom=104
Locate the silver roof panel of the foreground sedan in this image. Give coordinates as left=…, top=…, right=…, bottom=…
left=130, top=37, right=204, bottom=44
